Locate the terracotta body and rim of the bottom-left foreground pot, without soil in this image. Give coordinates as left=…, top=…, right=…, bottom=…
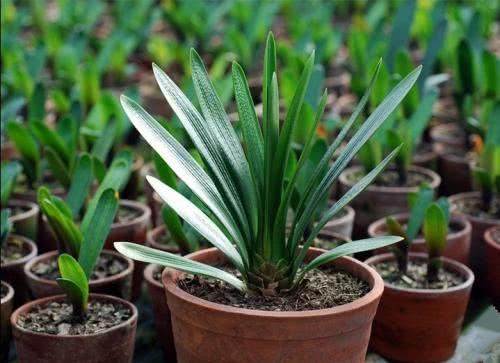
left=10, top=294, right=137, bottom=363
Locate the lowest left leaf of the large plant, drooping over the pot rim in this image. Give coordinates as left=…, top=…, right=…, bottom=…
left=114, top=242, right=246, bottom=291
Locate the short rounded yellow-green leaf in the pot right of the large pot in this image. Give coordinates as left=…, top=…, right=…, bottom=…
left=423, top=203, right=448, bottom=255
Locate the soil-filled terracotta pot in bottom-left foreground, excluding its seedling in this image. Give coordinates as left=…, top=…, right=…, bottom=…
left=11, top=294, right=137, bottom=363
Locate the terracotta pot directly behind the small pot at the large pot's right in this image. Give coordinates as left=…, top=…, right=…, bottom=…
left=368, top=213, right=472, bottom=265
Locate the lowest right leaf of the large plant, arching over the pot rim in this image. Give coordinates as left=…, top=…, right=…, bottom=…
left=304, top=236, right=403, bottom=273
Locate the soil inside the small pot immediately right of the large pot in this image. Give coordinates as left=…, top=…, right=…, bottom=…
left=375, top=260, right=465, bottom=290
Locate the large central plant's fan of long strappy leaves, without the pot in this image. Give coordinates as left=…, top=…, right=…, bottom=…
left=115, top=34, right=420, bottom=294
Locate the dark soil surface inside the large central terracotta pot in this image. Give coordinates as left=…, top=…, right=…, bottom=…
left=179, top=268, right=370, bottom=311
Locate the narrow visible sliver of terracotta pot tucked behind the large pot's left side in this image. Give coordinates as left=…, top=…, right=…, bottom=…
left=144, top=264, right=177, bottom=362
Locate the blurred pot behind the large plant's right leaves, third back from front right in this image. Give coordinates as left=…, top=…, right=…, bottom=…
left=339, top=166, right=441, bottom=238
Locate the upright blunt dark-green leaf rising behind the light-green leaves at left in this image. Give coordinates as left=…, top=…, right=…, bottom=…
left=66, top=153, right=94, bottom=219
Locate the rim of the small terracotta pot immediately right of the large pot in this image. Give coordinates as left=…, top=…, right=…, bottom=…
left=365, top=252, right=475, bottom=297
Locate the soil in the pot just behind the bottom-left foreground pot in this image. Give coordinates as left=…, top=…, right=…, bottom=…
left=31, top=254, right=127, bottom=280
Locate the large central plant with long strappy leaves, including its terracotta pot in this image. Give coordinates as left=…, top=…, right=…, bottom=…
left=115, top=35, right=419, bottom=362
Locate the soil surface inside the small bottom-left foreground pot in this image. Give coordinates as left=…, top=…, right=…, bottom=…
left=17, top=301, right=132, bottom=335
